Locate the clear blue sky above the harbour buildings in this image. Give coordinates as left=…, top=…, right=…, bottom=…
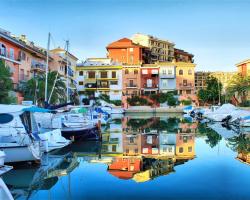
left=0, top=0, right=250, bottom=71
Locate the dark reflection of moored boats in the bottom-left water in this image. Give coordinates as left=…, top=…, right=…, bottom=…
left=3, top=153, right=79, bottom=199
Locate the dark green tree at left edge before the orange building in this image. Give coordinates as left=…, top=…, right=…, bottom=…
left=0, top=60, right=13, bottom=104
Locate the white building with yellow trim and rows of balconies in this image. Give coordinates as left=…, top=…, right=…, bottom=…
left=76, top=58, right=122, bottom=100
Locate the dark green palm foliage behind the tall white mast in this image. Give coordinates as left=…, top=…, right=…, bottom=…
left=19, top=71, right=66, bottom=105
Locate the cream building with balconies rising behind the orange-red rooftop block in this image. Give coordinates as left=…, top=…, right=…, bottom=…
left=131, top=33, right=175, bottom=63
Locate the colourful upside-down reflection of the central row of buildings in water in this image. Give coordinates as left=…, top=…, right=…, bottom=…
left=102, top=117, right=197, bottom=182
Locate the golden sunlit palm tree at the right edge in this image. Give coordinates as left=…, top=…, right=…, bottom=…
left=227, top=74, right=250, bottom=102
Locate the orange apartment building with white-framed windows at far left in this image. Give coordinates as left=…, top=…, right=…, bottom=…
left=0, top=29, right=46, bottom=103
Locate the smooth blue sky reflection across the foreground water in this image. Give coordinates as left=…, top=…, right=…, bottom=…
left=5, top=115, right=250, bottom=199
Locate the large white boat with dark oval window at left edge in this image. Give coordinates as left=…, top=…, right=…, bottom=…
left=0, top=104, right=41, bottom=163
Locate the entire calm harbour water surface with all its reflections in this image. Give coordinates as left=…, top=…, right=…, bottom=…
left=3, top=115, right=250, bottom=200
